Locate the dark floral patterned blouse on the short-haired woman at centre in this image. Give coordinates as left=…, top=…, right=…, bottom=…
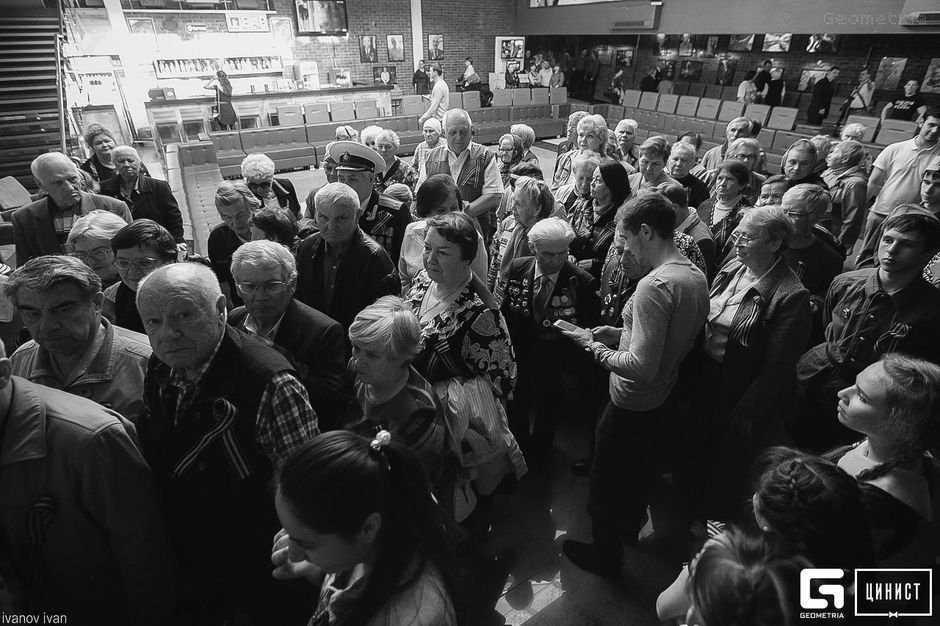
left=406, top=270, right=516, bottom=399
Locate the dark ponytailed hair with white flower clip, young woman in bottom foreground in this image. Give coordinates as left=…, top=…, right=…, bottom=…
left=276, top=430, right=458, bottom=625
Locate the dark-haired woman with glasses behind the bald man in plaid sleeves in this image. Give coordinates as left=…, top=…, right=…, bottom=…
left=102, top=219, right=179, bottom=333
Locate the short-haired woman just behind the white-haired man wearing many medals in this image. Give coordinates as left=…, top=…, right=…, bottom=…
left=486, top=176, right=555, bottom=303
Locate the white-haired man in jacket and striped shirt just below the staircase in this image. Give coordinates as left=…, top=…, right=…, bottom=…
left=13, top=152, right=133, bottom=265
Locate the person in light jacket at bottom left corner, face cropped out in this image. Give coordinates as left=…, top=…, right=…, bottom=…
left=0, top=338, right=179, bottom=626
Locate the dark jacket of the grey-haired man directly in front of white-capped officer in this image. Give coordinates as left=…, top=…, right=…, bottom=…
left=296, top=229, right=401, bottom=336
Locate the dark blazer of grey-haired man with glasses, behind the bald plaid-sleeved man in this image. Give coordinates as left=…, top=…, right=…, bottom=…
left=228, top=300, right=352, bottom=427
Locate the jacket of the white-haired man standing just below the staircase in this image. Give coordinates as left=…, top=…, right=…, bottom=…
left=13, top=191, right=134, bottom=265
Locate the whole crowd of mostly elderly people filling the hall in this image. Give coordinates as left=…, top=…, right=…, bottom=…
left=0, top=96, right=940, bottom=625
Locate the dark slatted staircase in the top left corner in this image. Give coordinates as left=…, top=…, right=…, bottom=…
left=0, top=11, right=61, bottom=190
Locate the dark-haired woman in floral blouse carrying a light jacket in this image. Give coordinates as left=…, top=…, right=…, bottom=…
left=406, top=210, right=524, bottom=519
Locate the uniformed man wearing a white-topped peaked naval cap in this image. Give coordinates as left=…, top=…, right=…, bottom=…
left=327, top=141, right=411, bottom=264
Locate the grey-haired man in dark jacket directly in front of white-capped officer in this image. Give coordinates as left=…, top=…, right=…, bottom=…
left=297, top=183, right=401, bottom=342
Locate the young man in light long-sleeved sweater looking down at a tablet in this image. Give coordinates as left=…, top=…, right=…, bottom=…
left=563, top=192, right=708, bottom=577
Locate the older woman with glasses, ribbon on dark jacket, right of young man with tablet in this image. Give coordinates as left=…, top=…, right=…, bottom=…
left=693, top=207, right=812, bottom=519
